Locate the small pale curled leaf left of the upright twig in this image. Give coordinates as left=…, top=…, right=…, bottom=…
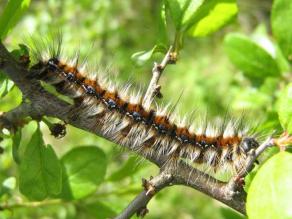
left=131, top=45, right=166, bottom=66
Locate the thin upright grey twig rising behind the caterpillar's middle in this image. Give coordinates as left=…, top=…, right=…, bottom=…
left=143, top=46, right=176, bottom=109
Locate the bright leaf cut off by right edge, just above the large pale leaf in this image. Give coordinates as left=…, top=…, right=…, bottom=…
left=277, top=83, right=292, bottom=134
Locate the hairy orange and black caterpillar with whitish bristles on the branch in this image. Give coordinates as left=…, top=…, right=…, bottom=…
left=27, top=36, right=259, bottom=180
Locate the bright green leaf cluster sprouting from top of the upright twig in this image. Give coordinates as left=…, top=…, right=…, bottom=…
left=165, top=0, right=238, bottom=51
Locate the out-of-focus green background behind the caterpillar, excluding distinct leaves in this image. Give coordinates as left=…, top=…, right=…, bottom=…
left=0, top=0, right=271, bottom=219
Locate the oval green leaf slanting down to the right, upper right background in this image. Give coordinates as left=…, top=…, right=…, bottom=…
left=224, top=33, right=281, bottom=81
